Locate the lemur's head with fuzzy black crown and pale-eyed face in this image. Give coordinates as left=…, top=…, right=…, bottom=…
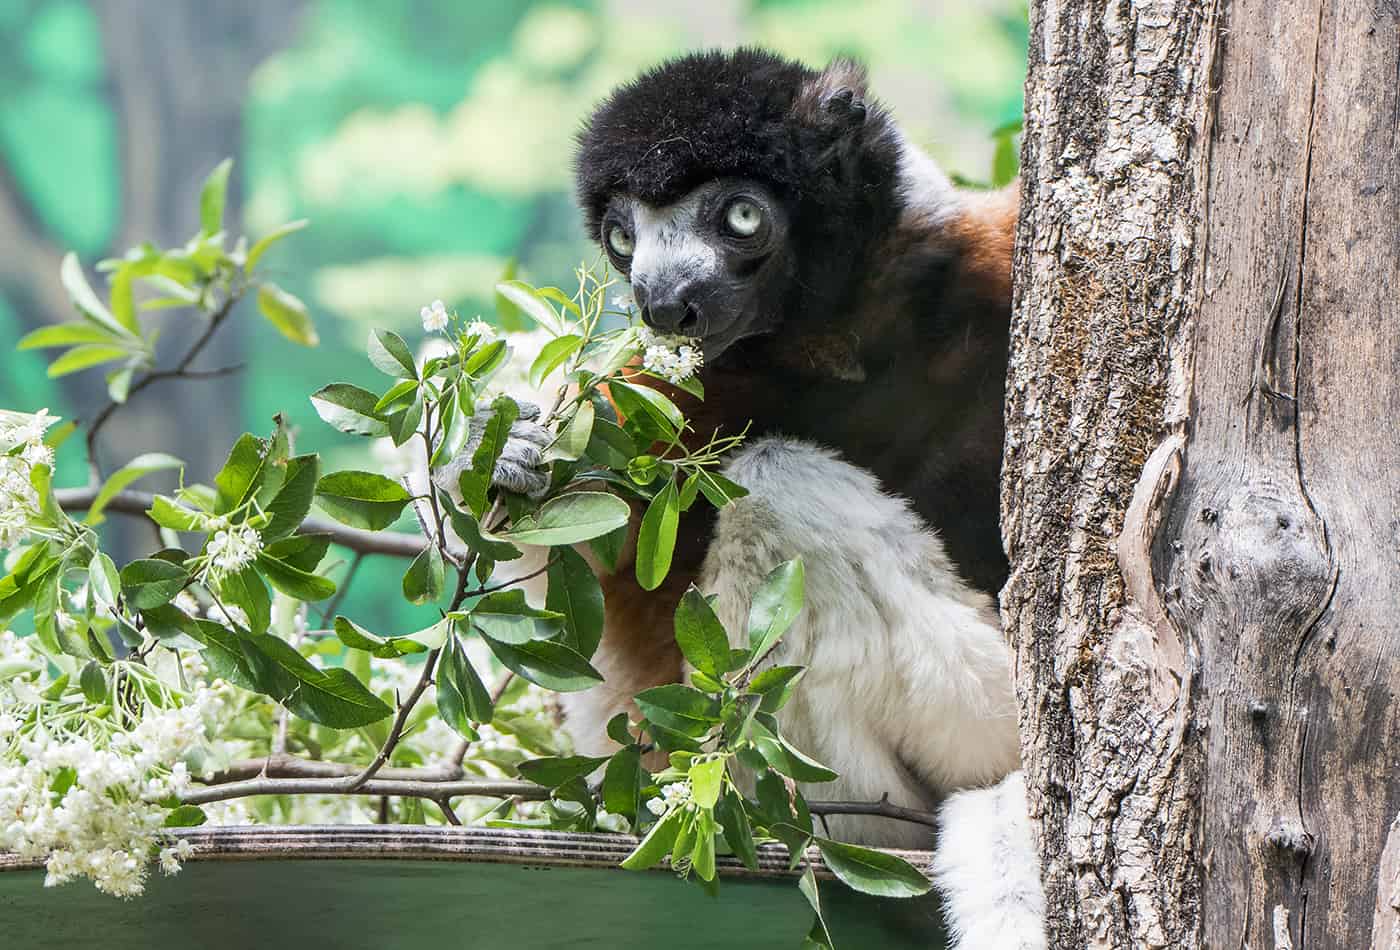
left=575, top=49, right=903, bottom=360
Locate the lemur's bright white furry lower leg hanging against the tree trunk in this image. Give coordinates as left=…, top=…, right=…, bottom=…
left=932, top=771, right=1046, bottom=950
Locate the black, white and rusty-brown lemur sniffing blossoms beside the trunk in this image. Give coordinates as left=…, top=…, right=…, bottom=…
left=436, top=49, right=1044, bottom=950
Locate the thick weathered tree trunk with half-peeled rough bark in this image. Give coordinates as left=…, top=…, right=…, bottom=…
left=1002, top=0, right=1400, bottom=950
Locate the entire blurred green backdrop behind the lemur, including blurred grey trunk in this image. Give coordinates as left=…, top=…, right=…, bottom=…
left=0, top=0, right=1026, bottom=631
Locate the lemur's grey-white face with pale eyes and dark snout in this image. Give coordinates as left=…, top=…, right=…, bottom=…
left=598, top=178, right=790, bottom=360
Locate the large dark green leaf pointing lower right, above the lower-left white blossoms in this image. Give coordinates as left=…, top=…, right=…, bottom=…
left=244, top=634, right=392, bottom=729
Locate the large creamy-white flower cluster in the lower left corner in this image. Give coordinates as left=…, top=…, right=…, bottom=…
left=0, top=631, right=225, bottom=897
